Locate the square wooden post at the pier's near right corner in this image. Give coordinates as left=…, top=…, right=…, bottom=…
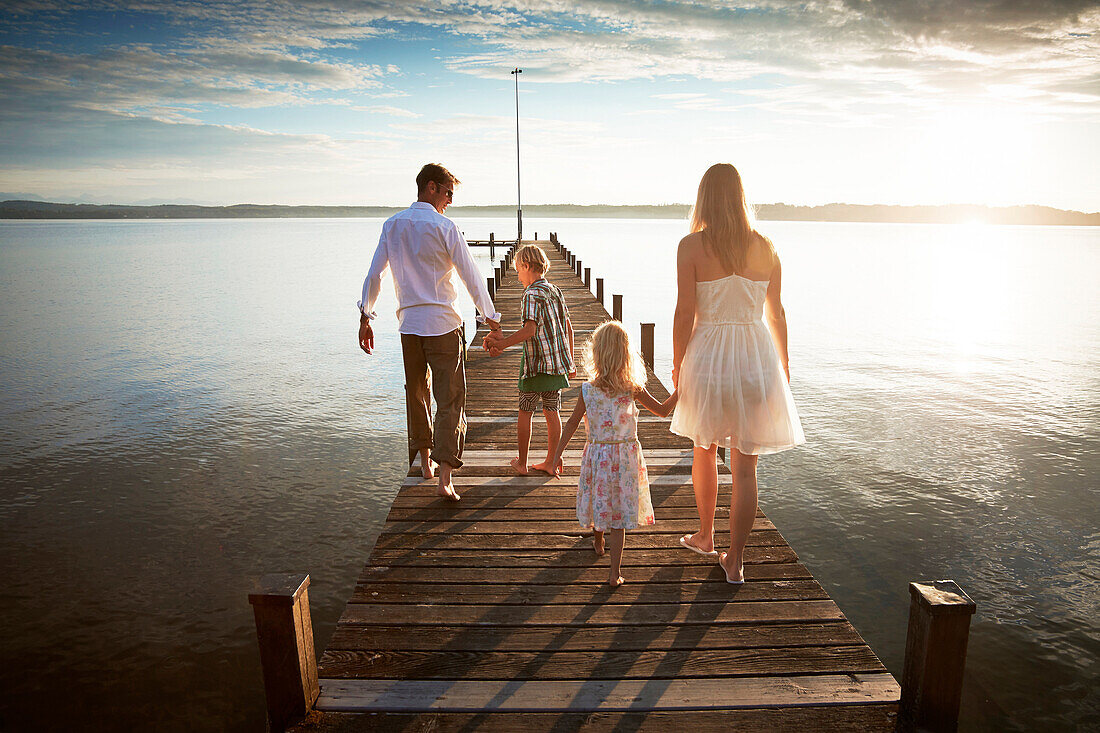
left=898, top=580, right=977, bottom=733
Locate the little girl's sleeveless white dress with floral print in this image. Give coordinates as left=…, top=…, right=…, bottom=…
left=576, top=382, right=653, bottom=532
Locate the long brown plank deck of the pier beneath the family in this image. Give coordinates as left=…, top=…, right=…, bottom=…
left=303, top=241, right=900, bottom=731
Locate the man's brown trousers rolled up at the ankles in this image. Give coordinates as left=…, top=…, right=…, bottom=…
left=402, top=329, right=466, bottom=468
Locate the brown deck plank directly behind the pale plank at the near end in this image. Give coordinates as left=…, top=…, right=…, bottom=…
left=318, top=644, right=886, bottom=680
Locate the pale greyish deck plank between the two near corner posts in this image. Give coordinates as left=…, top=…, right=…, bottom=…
left=317, top=672, right=899, bottom=712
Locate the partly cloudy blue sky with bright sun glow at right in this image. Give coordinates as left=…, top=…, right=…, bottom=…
left=0, top=0, right=1100, bottom=206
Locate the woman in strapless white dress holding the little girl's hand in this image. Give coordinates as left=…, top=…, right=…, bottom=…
left=671, top=163, right=805, bottom=584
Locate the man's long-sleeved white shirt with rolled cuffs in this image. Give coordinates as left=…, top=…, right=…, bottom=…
left=359, top=201, right=501, bottom=336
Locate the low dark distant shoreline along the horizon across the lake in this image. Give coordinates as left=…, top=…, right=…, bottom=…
left=0, top=200, right=1100, bottom=227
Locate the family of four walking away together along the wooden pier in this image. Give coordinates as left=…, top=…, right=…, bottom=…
left=359, top=164, right=804, bottom=586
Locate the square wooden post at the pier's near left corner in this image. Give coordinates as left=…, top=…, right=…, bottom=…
left=249, top=573, right=320, bottom=731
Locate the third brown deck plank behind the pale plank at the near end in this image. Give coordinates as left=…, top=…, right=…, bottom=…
left=340, top=598, right=844, bottom=626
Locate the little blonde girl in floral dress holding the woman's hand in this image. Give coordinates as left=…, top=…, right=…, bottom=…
left=551, top=320, right=677, bottom=587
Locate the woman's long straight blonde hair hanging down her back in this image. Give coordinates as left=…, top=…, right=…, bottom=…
left=691, top=163, right=776, bottom=274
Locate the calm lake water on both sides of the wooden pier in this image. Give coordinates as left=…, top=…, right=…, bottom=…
left=0, top=219, right=1100, bottom=731
